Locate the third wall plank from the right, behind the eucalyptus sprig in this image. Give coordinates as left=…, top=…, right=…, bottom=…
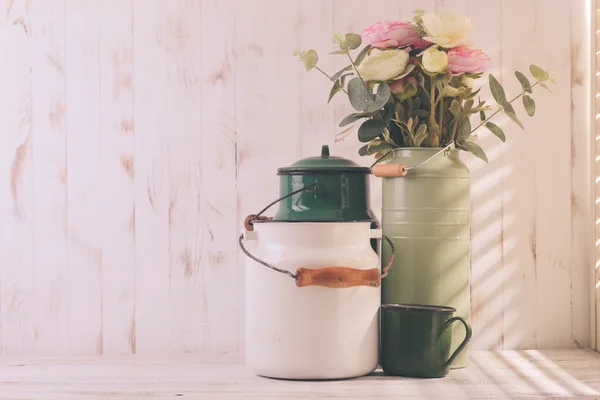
left=495, top=0, right=540, bottom=349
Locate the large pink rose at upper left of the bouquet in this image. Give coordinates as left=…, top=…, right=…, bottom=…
left=362, top=21, right=431, bottom=49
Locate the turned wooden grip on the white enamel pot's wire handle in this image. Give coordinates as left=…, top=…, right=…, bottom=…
left=296, top=267, right=381, bottom=288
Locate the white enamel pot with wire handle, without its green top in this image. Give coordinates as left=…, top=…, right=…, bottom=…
left=240, top=219, right=391, bottom=379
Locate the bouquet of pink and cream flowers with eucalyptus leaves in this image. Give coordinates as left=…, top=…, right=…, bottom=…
left=294, top=10, right=554, bottom=162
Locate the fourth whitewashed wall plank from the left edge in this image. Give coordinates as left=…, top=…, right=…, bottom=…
left=99, top=0, right=136, bottom=354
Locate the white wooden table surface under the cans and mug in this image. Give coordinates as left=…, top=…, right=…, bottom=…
left=0, top=350, right=600, bottom=400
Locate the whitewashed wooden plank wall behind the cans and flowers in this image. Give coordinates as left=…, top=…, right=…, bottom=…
left=0, top=0, right=592, bottom=355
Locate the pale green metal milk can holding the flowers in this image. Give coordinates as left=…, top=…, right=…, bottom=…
left=374, top=148, right=470, bottom=368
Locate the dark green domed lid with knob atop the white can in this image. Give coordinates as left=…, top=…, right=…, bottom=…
left=277, top=145, right=371, bottom=175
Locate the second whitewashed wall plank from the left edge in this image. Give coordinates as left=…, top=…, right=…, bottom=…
left=31, top=0, right=69, bottom=355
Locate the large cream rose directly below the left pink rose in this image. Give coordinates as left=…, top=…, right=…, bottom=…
left=358, top=50, right=408, bottom=82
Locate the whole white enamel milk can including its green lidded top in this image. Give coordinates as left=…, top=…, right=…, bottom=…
left=239, top=148, right=394, bottom=379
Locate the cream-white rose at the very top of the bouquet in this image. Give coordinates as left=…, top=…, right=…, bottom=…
left=423, top=13, right=471, bottom=48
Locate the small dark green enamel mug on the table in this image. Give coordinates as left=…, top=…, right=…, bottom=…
left=381, top=304, right=472, bottom=378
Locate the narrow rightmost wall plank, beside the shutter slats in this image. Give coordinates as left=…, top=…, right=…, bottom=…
left=570, top=2, right=595, bottom=347
